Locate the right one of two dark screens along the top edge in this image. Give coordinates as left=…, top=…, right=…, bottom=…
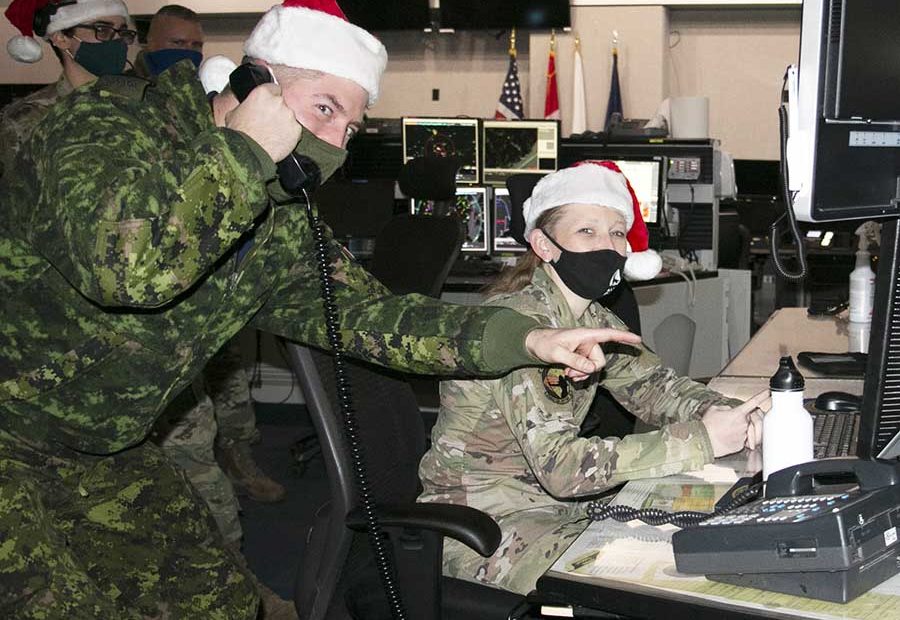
left=440, top=0, right=572, bottom=29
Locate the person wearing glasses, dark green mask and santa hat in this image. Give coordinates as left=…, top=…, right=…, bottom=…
left=0, top=0, right=137, bottom=177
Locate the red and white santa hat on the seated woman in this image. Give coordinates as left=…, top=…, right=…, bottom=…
left=522, top=160, right=662, bottom=280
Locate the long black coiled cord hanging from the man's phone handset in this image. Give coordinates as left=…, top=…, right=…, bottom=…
left=302, top=189, right=406, bottom=620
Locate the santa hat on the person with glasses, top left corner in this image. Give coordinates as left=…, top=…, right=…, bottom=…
left=4, top=0, right=130, bottom=62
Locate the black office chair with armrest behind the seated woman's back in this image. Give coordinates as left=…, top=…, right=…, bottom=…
left=287, top=344, right=524, bottom=620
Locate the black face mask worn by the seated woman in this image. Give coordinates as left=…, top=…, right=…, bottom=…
left=541, top=229, right=625, bottom=299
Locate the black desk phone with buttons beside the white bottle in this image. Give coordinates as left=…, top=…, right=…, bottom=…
left=672, top=458, right=900, bottom=603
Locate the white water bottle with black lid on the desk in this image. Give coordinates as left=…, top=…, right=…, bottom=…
left=763, top=355, right=813, bottom=480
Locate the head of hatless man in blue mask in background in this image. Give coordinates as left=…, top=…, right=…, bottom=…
left=134, top=4, right=206, bottom=79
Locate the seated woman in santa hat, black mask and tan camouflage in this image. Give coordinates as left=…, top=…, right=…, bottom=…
left=419, top=161, right=767, bottom=594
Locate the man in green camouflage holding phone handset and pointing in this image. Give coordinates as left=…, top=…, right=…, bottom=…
left=0, top=0, right=628, bottom=619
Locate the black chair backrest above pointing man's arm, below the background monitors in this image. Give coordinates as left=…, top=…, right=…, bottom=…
left=369, top=215, right=465, bottom=297
